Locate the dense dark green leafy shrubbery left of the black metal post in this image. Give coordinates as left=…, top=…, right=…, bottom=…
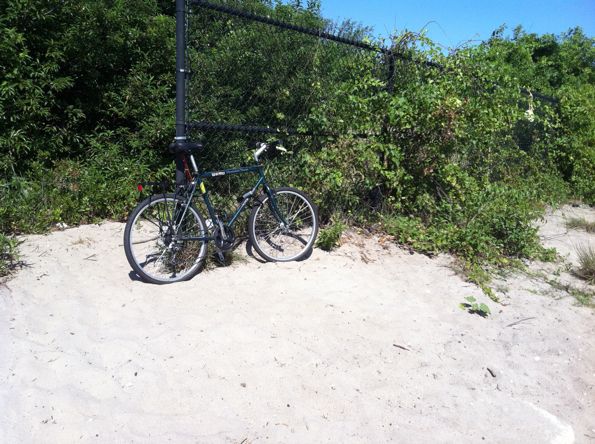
left=0, top=0, right=175, bottom=233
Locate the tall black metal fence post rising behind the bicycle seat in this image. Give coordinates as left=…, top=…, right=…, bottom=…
left=176, top=0, right=186, bottom=186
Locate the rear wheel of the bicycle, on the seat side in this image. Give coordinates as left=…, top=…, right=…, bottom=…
left=124, top=194, right=208, bottom=284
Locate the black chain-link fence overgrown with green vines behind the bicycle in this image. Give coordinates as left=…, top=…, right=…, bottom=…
left=186, top=0, right=556, bottom=219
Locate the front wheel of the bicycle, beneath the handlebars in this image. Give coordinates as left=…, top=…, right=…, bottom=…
left=248, top=187, right=318, bottom=262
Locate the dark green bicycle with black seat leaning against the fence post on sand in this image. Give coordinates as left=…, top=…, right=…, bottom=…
left=124, top=142, right=319, bottom=284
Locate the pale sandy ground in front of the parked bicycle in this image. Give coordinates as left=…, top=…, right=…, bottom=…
left=0, top=208, right=595, bottom=444
